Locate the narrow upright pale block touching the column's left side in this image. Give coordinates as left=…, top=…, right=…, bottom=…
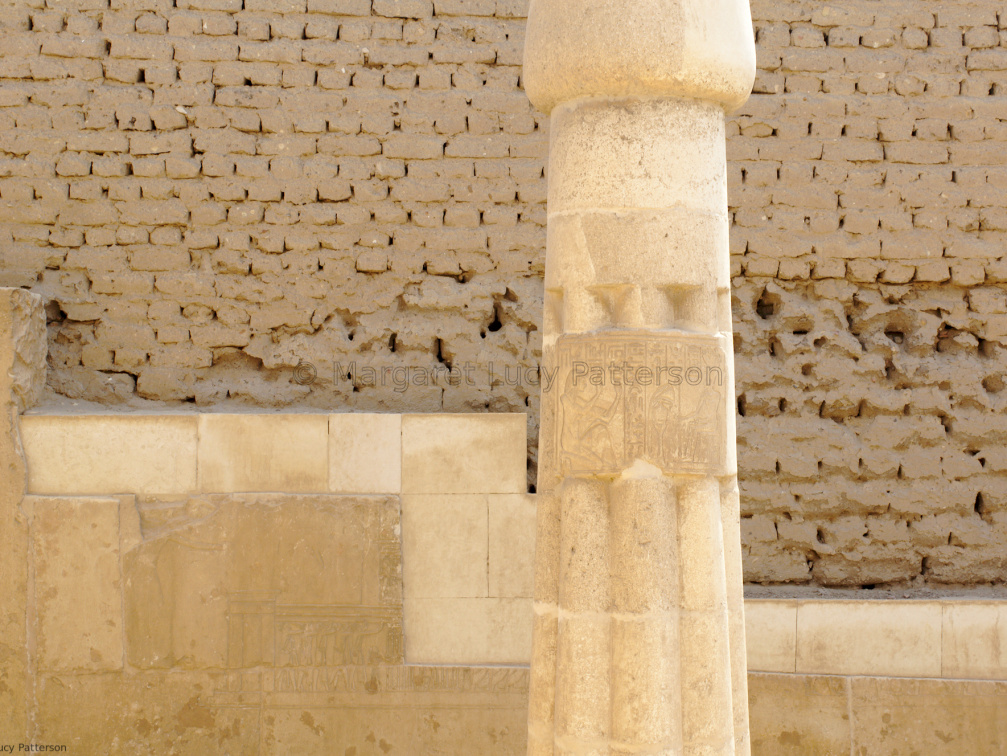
left=486, top=493, right=537, bottom=598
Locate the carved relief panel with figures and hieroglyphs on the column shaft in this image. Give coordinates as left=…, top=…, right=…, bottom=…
left=553, top=331, right=728, bottom=475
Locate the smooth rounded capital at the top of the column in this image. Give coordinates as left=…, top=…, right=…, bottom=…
left=524, top=0, right=755, bottom=113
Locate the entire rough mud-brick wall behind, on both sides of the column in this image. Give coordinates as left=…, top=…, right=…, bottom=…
left=0, top=0, right=1007, bottom=586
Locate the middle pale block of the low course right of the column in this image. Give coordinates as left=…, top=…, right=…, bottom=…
left=797, top=601, right=942, bottom=677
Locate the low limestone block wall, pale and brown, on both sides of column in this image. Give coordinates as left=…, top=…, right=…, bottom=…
left=11, top=410, right=1007, bottom=756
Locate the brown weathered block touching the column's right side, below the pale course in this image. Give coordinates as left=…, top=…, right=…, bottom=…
left=748, top=672, right=850, bottom=756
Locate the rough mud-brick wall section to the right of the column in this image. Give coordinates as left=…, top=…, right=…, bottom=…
left=728, top=2, right=1007, bottom=585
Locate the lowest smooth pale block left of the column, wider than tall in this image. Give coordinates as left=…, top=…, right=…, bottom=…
left=405, top=598, right=532, bottom=664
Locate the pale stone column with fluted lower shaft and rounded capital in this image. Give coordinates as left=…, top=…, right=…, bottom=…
left=524, top=0, right=755, bottom=756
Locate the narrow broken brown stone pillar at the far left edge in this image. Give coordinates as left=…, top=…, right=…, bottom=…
left=0, top=288, right=46, bottom=740
